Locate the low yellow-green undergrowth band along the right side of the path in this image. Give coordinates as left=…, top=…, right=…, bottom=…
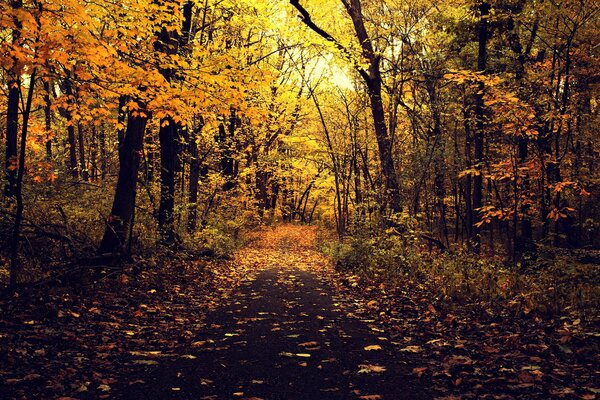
left=320, top=217, right=600, bottom=320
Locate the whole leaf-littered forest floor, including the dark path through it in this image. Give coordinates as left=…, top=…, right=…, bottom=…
left=0, top=225, right=600, bottom=400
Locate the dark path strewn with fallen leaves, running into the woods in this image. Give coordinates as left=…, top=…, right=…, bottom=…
left=119, top=226, right=431, bottom=400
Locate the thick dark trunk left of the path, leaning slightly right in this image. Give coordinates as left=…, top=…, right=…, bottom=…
left=98, top=103, right=148, bottom=254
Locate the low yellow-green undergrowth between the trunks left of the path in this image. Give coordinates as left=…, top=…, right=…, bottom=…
left=0, top=180, right=258, bottom=287
